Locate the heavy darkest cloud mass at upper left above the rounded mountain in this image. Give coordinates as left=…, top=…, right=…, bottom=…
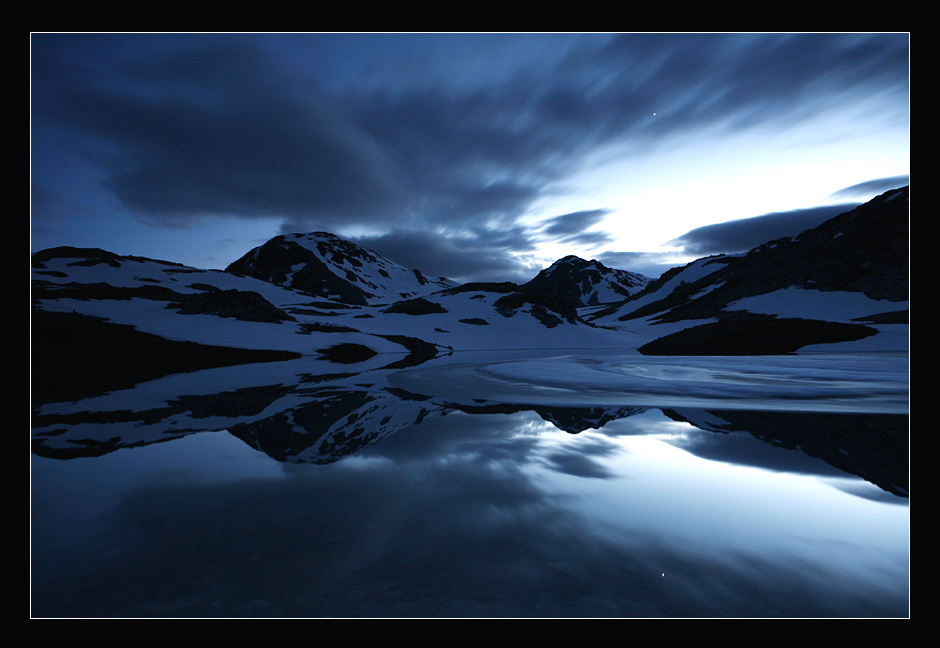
left=34, top=41, right=404, bottom=227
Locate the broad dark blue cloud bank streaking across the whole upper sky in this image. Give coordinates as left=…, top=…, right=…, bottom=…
left=33, top=34, right=908, bottom=235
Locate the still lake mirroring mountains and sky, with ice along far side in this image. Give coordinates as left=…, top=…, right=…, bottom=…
left=30, top=358, right=910, bottom=618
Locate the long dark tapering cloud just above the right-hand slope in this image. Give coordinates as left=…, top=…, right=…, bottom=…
left=669, top=203, right=857, bottom=257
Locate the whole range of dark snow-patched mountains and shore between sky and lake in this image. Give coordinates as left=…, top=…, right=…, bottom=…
left=31, top=187, right=909, bottom=408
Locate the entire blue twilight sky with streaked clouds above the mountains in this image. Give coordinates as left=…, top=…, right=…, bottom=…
left=30, top=33, right=910, bottom=282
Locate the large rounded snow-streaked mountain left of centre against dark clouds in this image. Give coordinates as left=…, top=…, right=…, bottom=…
left=226, top=232, right=455, bottom=306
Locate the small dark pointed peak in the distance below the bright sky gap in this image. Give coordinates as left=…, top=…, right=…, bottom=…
left=523, top=255, right=652, bottom=307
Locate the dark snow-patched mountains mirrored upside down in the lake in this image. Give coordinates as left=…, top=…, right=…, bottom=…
left=33, top=358, right=908, bottom=497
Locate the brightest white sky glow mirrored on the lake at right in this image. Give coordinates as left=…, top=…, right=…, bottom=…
left=516, top=416, right=907, bottom=550
